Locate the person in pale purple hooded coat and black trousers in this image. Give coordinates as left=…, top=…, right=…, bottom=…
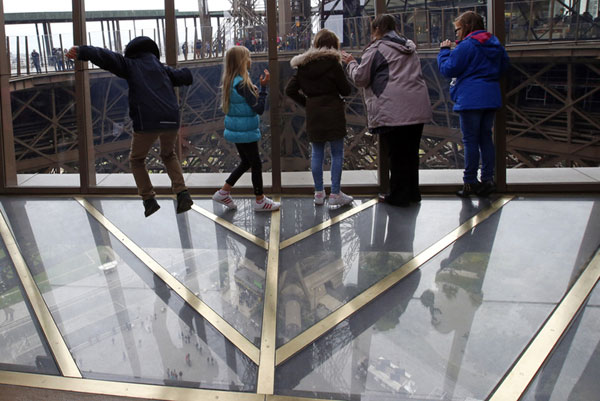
left=342, top=14, right=432, bottom=207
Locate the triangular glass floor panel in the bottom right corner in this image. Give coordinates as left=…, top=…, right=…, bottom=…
left=522, top=278, right=600, bottom=401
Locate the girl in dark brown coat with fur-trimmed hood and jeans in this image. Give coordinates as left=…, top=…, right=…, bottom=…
left=285, top=29, right=353, bottom=206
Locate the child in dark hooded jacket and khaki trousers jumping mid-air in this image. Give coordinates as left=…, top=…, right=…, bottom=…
left=67, top=36, right=194, bottom=217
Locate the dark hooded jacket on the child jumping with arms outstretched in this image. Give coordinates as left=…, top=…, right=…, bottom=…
left=77, top=36, right=193, bottom=131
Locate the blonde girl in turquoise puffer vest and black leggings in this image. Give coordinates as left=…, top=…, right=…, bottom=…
left=213, top=46, right=280, bottom=212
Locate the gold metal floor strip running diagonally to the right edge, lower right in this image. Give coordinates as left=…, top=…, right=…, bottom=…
left=488, top=248, right=600, bottom=401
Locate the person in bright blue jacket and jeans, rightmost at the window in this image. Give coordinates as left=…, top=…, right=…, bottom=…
left=438, top=11, right=509, bottom=198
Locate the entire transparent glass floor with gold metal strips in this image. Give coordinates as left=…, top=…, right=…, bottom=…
left=0, top=195, right=600, bottom=401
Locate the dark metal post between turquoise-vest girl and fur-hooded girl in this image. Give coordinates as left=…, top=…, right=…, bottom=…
left=266, top=0, right=285, bottom=193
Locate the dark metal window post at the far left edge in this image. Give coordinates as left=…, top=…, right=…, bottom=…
left=0, top=0, right=17, bottom=189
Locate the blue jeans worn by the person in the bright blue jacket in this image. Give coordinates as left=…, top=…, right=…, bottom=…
left=459, top=110, right=496, bottom=184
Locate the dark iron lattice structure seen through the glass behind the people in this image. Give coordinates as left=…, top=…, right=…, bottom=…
left=11, top=57, right=600, bottom=174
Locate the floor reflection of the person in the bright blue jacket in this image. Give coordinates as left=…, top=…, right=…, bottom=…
left=421, top=198, right=500, bottom=398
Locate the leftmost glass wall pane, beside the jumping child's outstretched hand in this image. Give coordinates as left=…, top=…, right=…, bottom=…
left=4, top=0, right=79, bottom=187
